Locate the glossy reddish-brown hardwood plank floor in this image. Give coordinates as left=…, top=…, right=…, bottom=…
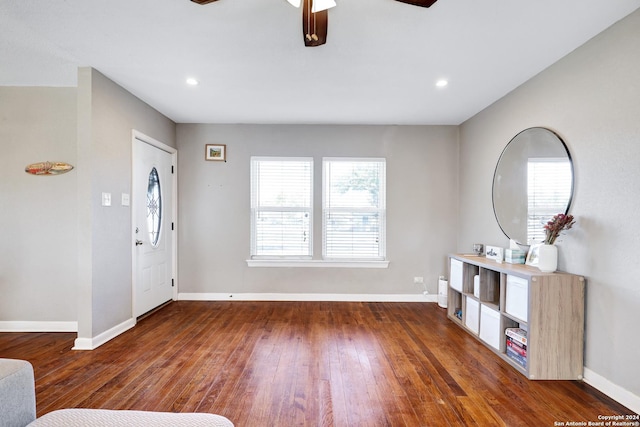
left=0, top=301, right=632, bottom=427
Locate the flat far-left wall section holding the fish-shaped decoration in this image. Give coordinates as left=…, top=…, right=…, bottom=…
left=0, top=87, right=77, bottom=327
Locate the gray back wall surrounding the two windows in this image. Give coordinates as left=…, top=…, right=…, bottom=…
left=178, top=124, right=458, bottom=295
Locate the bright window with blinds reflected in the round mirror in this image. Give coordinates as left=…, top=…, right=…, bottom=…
left=527, top=158, right=573, bottom=244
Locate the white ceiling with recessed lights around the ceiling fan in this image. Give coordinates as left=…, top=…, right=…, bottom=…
left=0, top=0, right=640, bottom=124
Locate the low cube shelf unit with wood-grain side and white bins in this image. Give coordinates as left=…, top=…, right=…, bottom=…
left=447, top=255, right=585, bottom=380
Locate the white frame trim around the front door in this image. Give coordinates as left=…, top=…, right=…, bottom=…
left=131, top=129, right=178, bottom=320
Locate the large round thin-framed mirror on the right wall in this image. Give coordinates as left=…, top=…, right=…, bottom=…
left=492, top=127, right=574, bottom=245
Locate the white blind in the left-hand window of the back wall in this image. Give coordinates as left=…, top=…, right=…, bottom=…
left=251, top=157, right=313, bottom=258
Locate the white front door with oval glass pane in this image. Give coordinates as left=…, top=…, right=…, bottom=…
left=131, top=137, right=174, bottom=317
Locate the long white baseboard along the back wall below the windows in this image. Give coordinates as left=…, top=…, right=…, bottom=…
left=178, top=292, right=438, bottom=302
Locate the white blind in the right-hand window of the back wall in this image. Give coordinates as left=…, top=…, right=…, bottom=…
left=322, top=158, right=386, bottom=260
